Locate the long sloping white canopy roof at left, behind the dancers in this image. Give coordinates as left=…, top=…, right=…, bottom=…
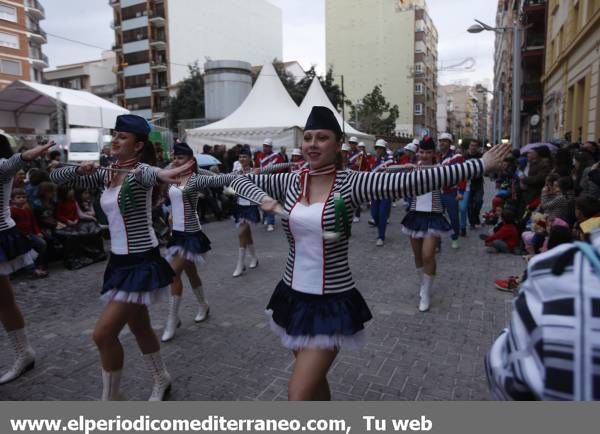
left=0, top=80, right=129, bottom=133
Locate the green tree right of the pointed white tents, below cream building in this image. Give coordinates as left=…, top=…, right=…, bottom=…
left=350, top=85, right=400, bottom=136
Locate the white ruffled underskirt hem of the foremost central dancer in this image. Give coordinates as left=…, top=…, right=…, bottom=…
left=265, top=310, right=367, bottom=351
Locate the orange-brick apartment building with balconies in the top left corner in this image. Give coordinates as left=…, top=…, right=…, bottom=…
left=0, top=0, right=48, bottom=88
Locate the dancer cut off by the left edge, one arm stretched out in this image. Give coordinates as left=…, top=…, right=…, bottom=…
left=0, top=135, right=54, bottom=384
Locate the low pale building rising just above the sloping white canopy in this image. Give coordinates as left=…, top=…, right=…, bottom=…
left=44, top=51, right=117, bottom=102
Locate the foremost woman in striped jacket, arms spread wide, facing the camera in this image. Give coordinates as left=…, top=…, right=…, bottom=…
left=232, top=107, right=509, bottom=400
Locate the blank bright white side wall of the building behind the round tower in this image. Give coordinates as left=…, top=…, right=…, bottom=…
left=167, top=0, right=283, bottom=85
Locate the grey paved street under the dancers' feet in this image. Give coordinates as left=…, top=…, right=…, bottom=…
left=0, top=192, right=523, bottom=400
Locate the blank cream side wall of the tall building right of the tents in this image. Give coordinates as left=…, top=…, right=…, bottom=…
left=325, top=0, right=415, bottom=134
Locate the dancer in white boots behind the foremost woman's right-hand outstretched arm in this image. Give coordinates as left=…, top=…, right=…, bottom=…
left=401, top=136, right=452, bottom=312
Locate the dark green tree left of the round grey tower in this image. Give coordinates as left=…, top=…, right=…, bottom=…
left=168, top=62, right=205, bottom=128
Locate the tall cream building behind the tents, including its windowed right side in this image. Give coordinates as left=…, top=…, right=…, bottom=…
left=325, top=0, right=438, bottom=137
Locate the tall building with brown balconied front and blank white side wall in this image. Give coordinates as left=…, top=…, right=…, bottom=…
left=109, top=0, right=283, bottom=119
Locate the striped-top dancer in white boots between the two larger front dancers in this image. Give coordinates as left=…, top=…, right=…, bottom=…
left=162, top=143, right=272, bottom=342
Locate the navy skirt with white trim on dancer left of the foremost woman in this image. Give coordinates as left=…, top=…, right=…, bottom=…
left=101, top=247, right=175, bottom=305
